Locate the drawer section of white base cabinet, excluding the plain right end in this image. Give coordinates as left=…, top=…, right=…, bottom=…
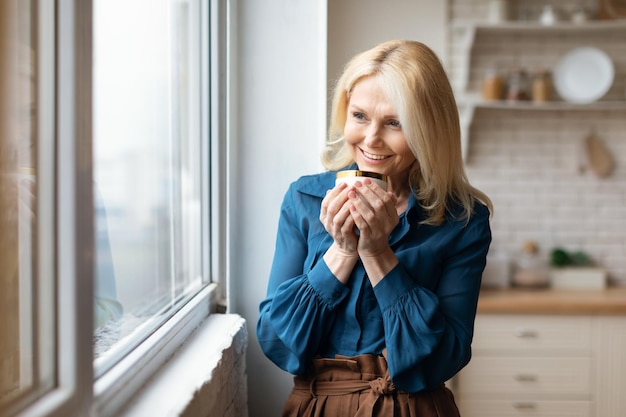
left=456, top=315, right=593, bottom=417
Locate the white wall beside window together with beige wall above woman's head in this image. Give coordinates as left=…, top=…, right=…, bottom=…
left=230, top=0, right=446, bottom=417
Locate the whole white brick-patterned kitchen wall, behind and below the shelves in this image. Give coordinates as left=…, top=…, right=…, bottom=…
left=448, top=0, right=626, bottom=285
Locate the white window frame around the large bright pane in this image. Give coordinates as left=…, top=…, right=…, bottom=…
left=18, top=0, right=230, bottom=417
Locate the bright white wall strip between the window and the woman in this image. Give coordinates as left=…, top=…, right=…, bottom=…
left=230, top=0, right=326, bottom=417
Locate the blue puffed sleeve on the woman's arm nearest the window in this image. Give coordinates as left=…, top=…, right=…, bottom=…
left=257, top=185, right=349, bottom=375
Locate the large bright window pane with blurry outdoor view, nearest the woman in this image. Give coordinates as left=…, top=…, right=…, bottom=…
left=94, top=0, right=208, bottom=374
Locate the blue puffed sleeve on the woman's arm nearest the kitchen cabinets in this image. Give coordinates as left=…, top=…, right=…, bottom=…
left=374, top=205, right=491, bottom=392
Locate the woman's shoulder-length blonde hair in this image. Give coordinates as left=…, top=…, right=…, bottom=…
left=322, top=40, right=493, bottom=224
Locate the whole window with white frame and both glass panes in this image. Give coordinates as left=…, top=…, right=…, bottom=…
left=0, top=0, right=225, bottom=416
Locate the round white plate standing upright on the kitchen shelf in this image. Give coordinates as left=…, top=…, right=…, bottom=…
left=553, top=47, right=615, bottom=104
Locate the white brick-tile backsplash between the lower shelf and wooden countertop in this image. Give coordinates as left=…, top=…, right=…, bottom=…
left=467, top=110, right=626, bottom=285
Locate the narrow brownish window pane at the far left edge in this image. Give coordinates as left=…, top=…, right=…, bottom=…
left=0, top=0, right=55, bottom=414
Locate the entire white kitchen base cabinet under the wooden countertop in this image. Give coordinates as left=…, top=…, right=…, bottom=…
left=454, top=314, right=626, bottom=417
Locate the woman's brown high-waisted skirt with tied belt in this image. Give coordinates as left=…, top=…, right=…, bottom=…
left=282, top=355, right=459, bottom=417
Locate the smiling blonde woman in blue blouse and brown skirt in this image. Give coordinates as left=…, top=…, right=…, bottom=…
left=257, top=41, right=491, bottom=417
